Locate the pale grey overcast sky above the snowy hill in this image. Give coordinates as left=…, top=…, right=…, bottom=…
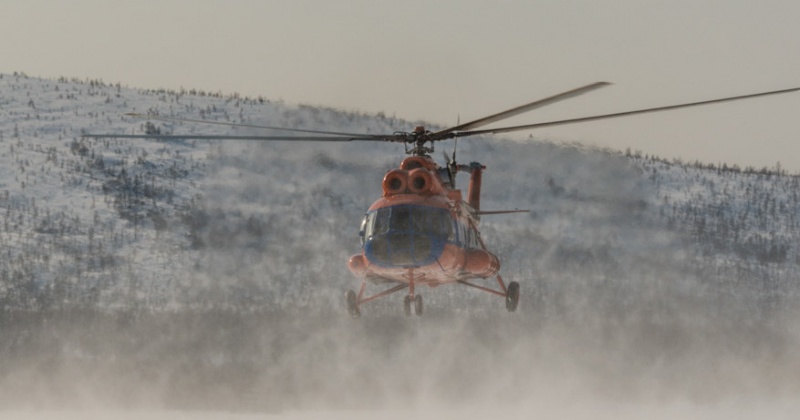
left=0, top=0, right=800, bottom=172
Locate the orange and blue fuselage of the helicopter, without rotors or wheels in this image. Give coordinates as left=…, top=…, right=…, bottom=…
left=349, top=156, right=500, bottom=287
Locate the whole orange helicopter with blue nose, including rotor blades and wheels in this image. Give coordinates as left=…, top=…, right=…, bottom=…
left=83, top=82, right=800, bottom=318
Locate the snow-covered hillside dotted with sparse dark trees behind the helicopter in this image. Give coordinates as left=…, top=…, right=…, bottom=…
left=0, top=70, right=798, bottom=316
